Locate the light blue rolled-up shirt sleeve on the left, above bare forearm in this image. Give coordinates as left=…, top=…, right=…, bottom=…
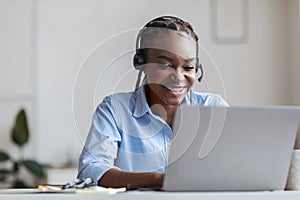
left=78, top=97, right=121, bottom=185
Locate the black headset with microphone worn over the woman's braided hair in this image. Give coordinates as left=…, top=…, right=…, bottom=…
left=133, top=16, right=203, bottom=89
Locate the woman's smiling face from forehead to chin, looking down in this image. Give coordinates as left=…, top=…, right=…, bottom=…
left=144, top=33, right=196, bottom=106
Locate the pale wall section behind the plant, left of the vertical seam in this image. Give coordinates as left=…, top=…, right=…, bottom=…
left=0, top=0, right=36, bottom=159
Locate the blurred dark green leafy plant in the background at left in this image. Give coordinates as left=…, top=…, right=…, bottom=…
left=0, top=109, right=46, bottom=188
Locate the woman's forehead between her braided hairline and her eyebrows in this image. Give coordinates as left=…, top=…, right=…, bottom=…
left=141, top=30, right=197, bottom=58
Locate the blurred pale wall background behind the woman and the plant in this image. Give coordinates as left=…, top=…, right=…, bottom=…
left=0, top=0, right=300, bottom=180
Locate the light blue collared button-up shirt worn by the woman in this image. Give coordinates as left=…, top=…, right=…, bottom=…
left=78, top=87, right=228, bottom=183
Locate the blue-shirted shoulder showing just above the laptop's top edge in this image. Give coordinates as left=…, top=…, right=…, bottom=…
left=193, top=92, right=228, bottom=106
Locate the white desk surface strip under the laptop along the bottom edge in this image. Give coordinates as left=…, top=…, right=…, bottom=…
left=0, top=191, right=300, bottom=200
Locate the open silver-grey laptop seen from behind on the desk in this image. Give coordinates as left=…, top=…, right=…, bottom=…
left=162, top=106, right=300, bottom=191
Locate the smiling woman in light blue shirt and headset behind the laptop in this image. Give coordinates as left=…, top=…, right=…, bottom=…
left=78, top=16, right=227, bottom=187
